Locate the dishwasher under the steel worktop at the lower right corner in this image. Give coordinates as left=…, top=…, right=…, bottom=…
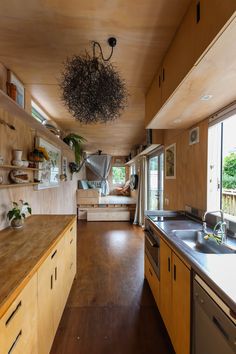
left=192, top=275, right=236, bottom=354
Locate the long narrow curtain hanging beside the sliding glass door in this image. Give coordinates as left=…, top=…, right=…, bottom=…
left=134, top=156, right=147, bottom=226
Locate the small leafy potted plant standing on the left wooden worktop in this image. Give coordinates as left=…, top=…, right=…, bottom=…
left=7, top=200, right=32, bottom=229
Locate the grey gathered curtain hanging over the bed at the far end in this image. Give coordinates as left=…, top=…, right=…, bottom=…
left=86, top=154, right=112, bottom=195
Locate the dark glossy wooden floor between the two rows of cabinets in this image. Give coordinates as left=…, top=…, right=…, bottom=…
left=51, top=222, right=174, bottom=354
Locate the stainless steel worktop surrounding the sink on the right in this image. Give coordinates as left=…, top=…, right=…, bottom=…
left=149, top=216, right=236, bottom=313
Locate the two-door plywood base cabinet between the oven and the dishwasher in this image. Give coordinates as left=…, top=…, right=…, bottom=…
left=160, top=239, right=191, bottom=354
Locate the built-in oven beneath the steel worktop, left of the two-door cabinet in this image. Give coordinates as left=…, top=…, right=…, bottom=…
left=144, top=219, right=160, bottom=279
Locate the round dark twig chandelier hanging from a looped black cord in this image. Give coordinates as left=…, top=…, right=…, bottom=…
left=60, top=38, right=127, bottom=124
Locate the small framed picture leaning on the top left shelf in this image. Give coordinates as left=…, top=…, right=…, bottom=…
left=7, top=70, right=25, bottom=108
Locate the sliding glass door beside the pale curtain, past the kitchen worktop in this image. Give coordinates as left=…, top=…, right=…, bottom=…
left=147, top=149, right=164, bottom=210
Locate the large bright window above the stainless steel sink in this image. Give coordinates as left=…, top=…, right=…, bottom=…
left=207, top=110, right=236, bottom=221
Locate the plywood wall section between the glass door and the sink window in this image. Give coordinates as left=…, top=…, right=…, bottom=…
left=164, top=120, right=208, bottom=210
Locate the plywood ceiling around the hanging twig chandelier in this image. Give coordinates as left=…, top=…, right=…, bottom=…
left=0, top=0, right=190, bottom=155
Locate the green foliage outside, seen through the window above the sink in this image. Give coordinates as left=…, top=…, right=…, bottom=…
left=223, top=152, right=236, bottom=189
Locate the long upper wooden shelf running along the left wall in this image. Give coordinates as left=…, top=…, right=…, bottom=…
left=0, top=90, right=71, bottom=151
